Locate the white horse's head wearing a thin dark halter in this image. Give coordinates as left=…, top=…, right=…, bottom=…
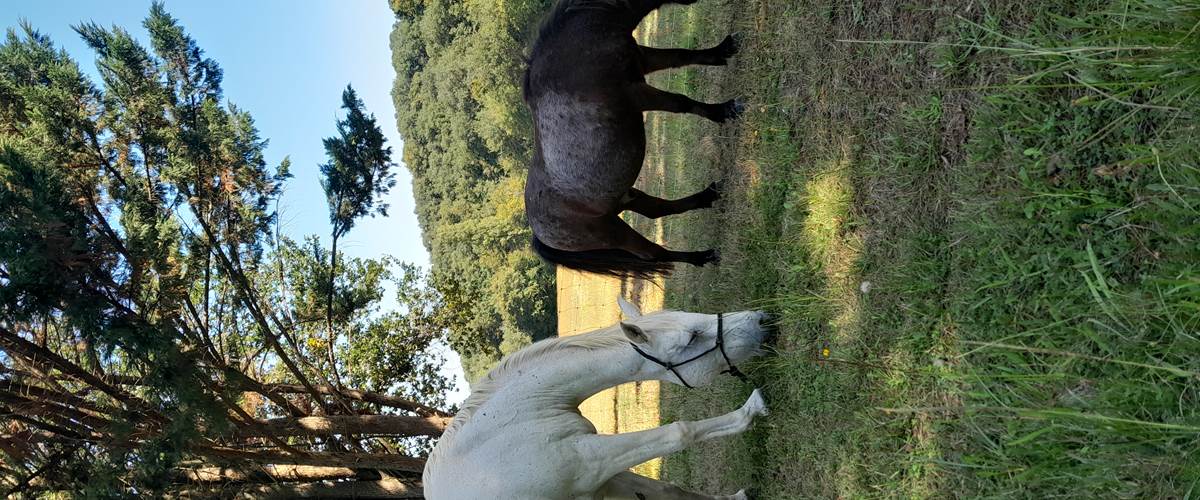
left=617, top=293, right=769, bottom=387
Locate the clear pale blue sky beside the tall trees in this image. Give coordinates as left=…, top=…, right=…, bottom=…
left=0, top=0, right=466, bottom=402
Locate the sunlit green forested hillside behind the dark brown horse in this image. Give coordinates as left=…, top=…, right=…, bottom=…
left=391, top=0, right=556, bottom=379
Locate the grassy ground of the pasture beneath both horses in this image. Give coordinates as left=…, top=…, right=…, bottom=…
left=635, top=0, right=1200, bottom=499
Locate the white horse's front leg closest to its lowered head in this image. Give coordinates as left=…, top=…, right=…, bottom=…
left=576, top=388, right=767, bottom=477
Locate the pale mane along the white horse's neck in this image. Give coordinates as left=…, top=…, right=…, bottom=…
left=442, top=325, right=629, bottom=440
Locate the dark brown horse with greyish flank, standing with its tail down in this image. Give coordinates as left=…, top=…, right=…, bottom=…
left=524, top=0, right=742, bottom=277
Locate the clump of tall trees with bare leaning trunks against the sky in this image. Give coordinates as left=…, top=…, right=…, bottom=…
left=0, top=4, right=453, bottom=498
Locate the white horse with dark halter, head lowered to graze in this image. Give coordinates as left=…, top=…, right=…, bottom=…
left=424, top=299, right=767, bottom=500
